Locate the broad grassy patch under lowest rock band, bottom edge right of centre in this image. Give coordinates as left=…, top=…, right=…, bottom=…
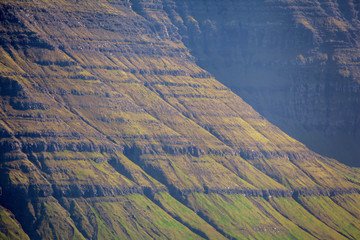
left=188, top=193, right=315, bottom=239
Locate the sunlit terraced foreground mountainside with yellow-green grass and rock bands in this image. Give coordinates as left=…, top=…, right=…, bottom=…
left=0, top=0, right=360, bottom=239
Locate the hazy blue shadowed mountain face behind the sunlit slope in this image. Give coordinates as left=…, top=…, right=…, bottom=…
left=170, top=0, right=360, bottom=166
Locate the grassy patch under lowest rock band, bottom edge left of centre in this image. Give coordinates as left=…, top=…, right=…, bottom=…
left=65, top=194, right=202, bottom=239
